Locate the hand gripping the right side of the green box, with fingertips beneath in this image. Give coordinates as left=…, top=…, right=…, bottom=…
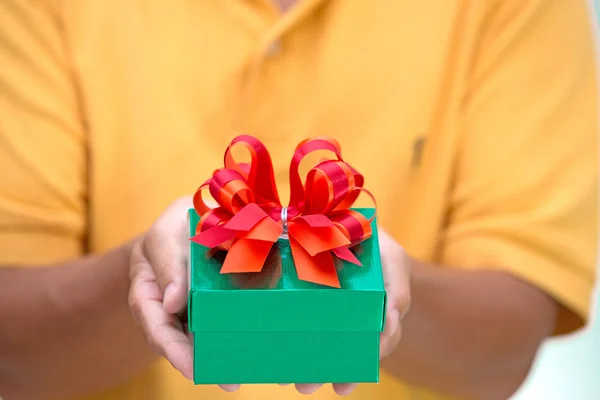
left=296, top=229, right=413, bottom=396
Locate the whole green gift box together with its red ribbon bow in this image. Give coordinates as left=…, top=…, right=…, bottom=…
left=188, top=136, right=386, bottom=384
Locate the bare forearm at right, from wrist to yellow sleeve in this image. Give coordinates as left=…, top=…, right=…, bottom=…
left=382, top=264, right=558, bottom=400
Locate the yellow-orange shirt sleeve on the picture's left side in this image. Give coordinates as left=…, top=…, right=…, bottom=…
left=0, top=0, right=86, bottom=266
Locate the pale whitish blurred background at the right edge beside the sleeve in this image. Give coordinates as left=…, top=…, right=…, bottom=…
left=512, top=0, right=600, bottom=400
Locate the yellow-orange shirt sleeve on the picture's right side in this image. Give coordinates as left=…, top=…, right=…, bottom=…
left=442, top=0, right=599, bottom=333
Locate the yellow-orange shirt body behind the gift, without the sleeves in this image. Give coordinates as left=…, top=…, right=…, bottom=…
left=58, top=0, right=476, bottom=400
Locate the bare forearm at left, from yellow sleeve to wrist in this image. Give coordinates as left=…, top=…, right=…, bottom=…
left=0, top=238, right=157, bottom=400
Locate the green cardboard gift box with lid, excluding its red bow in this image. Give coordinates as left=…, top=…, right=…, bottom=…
left=188, top=209, right=386, bottom=384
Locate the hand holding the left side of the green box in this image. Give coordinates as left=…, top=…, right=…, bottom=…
left=129, top=197, right=239, bottom=391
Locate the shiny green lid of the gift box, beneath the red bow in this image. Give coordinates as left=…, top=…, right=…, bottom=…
left=188, top=209, right=385, bottom=332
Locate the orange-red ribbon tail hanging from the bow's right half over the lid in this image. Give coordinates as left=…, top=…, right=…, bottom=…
left=290, top=237, right=340, bottom=288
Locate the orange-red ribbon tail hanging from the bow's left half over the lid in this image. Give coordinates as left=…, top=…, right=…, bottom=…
left=221, top=239, right=273, bottom=274
